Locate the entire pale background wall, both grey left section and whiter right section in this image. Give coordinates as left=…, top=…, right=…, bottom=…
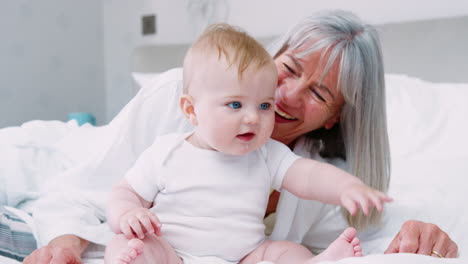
left=0, top=0, right=468, bottom=127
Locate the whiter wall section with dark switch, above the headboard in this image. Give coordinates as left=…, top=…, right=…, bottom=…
left=104, top=0, right=468, bottom=119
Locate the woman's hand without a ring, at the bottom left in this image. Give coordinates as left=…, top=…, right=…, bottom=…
left=23, top=235, right=89, bottom=264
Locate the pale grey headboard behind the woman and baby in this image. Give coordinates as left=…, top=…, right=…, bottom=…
left=131, top=16, right=468, bottom=82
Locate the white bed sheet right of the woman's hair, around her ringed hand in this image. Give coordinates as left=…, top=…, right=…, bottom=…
left=329, top=74, right=468, bottom=264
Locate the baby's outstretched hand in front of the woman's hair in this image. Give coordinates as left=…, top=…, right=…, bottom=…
left=340, top=183, right=393, bottom=215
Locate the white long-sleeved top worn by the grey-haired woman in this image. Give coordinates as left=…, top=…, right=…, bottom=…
left=28, top=68, right=380, bottom=256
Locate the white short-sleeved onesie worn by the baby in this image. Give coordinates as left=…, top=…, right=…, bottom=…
left=125, top=133, right=300, bottom=262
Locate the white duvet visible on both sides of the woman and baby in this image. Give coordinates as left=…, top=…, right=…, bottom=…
left=0, top=75, right=468, bottom=264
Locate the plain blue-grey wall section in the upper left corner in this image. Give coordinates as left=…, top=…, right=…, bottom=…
left=0, top=0, right=105, bottom=127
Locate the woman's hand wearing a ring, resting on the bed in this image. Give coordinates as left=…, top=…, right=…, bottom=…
left=385, top=220, right=458, bottom=258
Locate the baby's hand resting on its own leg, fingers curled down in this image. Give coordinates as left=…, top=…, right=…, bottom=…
left=120, top=207, right=161, bottom=239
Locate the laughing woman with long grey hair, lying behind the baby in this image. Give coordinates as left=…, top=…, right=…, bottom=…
left=25, top=11, right=457, bottom=263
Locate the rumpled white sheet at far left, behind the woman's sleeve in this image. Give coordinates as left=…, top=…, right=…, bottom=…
left=0, top=120, right=104, bottom=211
